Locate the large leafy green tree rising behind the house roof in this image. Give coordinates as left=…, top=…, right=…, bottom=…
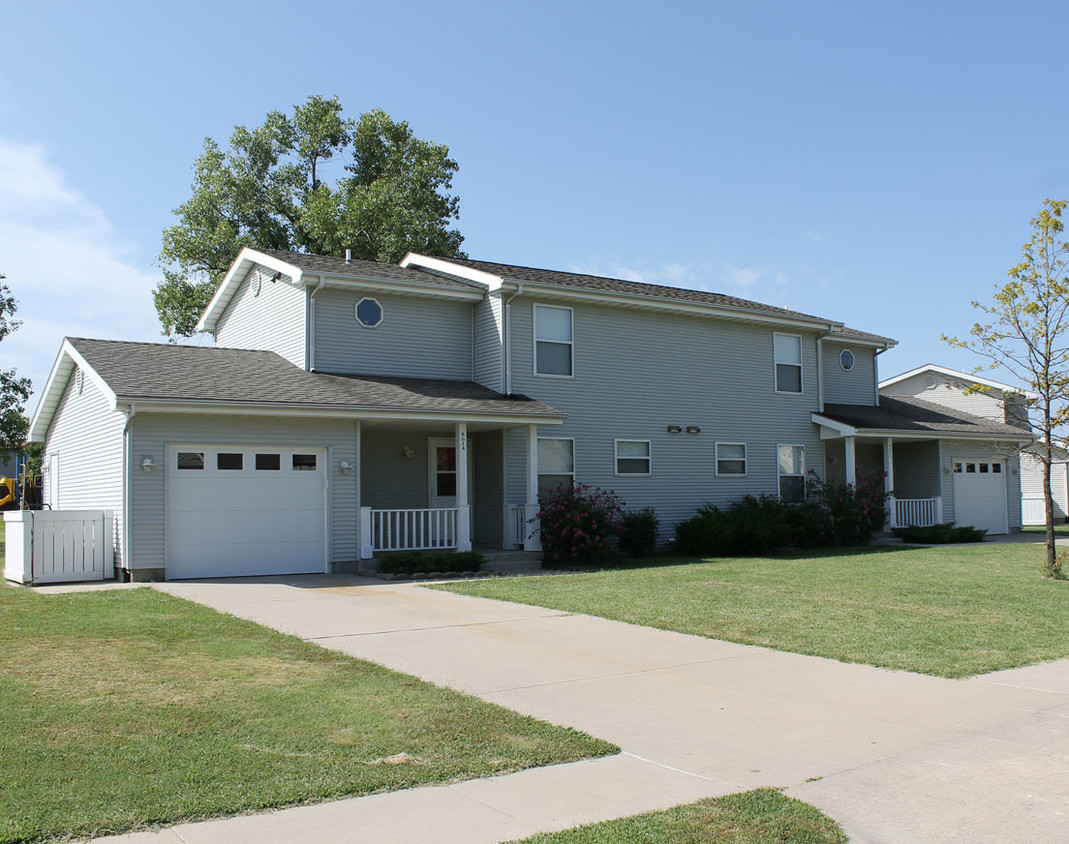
left=153, top=96, right=464, bottom=337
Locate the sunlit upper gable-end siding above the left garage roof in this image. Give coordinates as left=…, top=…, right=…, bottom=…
left=215, top=269, right=307, bottom=369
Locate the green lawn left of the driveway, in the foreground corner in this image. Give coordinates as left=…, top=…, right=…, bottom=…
left=0, top=588, right=615, bottom=842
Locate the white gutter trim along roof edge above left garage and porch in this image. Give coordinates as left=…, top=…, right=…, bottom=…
left=120, top=396, right=567, bottom=425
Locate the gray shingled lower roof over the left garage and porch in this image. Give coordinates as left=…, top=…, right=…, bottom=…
left=67, top=338, right=564, bottom=421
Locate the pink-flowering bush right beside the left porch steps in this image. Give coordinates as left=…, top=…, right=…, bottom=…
left=538, top=484, right=623, bottom=563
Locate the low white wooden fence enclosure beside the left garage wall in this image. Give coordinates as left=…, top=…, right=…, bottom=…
left=3, top=510, right=115, bottom=583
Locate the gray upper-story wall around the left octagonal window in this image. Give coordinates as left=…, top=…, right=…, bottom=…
left=313, top=287, right=472, bottom=380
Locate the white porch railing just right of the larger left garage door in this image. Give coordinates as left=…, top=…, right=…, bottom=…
left=360, top=506, right=471, bottom=560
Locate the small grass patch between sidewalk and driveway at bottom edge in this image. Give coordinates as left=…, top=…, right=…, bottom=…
left=504, top=788, right=847, bottom=844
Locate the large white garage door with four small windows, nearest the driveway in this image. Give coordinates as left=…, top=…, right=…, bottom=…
left=166, top=446, right=327, bottom=579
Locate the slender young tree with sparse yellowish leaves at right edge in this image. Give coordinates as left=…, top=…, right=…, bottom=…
left=943, top=200, right=1069, bottom=577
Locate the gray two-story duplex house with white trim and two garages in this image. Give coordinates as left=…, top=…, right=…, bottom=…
left=31, top=249, right=1031, bottom=579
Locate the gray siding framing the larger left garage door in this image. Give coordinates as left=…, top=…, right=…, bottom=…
left=130, top=413, right=359, bottom=568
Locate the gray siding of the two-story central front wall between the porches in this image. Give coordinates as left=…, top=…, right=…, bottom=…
left=507, top=297, right=823, bottom=535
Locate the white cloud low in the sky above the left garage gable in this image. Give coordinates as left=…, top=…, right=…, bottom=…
left=0, top=138, right=162, bottom=410
